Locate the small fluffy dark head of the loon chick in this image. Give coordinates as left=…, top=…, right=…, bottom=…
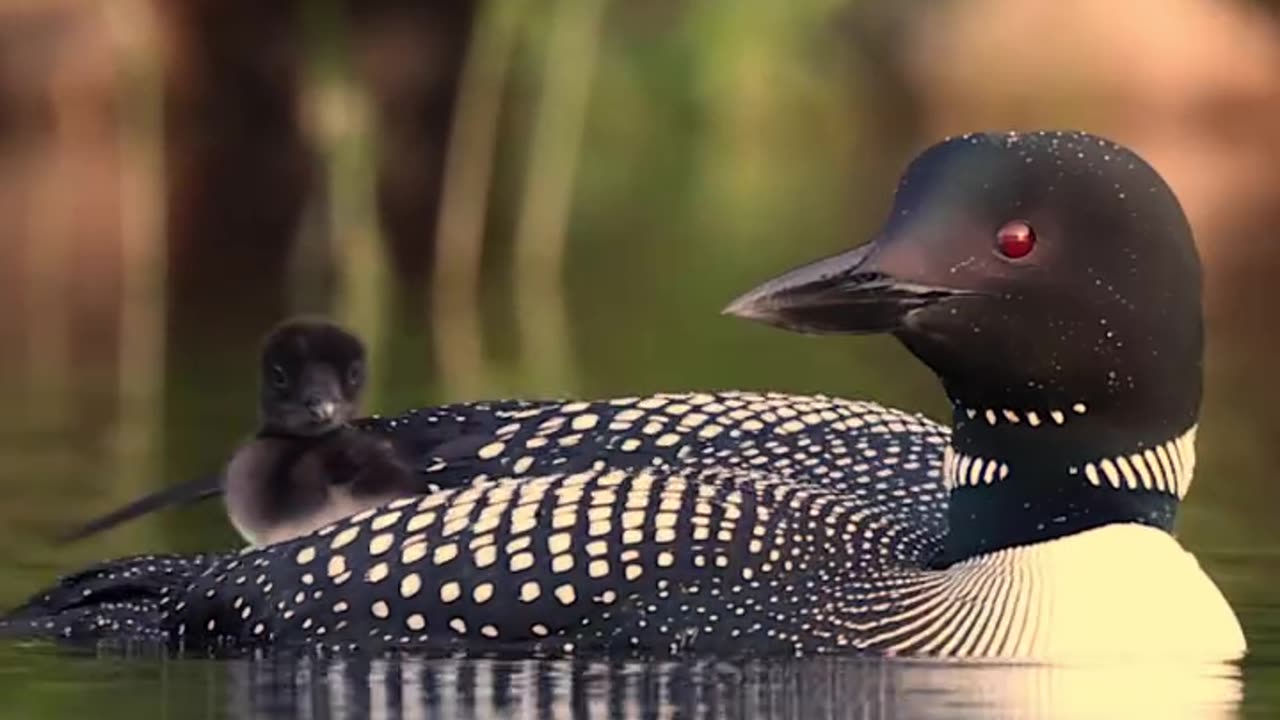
left=259, top=319, right=365, bottom=437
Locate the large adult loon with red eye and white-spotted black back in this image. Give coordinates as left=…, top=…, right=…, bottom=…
left=6, top=132, right=1245, bottom=661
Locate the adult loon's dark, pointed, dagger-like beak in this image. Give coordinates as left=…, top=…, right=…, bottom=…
left=723, top=242, right=970, bottom=334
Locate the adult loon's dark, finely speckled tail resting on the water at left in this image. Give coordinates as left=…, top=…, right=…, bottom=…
left=0, top=555, right=221, bottom=644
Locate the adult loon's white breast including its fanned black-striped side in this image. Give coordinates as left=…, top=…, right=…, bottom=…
left=865, top=524, right=1245, bottom=662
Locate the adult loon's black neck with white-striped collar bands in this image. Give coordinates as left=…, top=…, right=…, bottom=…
left=936, top=404, right=1196, bottom=565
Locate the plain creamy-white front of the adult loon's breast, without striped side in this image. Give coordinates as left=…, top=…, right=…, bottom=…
left=945, top=524, right=1245, bottom=662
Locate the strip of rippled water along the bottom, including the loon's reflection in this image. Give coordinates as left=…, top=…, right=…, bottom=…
left=0, top=650, right=1276, bottom=719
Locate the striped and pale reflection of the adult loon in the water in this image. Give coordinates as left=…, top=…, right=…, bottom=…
left=227, top=655, right=1242, bottom=720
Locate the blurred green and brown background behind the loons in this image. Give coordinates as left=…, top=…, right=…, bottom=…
left=0, top=0, right=1280, bottom=702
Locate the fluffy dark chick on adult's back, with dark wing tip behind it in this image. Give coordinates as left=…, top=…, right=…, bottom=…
left=69, top=318, right=421, bottom=546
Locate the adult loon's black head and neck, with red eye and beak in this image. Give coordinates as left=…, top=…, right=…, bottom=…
left=726, top=132, right=1203, bottom=556
